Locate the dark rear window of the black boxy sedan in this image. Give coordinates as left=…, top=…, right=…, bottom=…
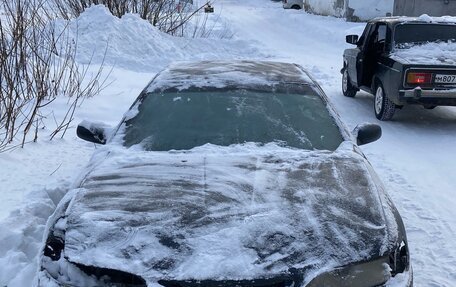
left=394, top=24, right=456, bottom=48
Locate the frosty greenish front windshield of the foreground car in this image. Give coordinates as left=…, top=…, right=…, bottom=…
left=124, top=89, right=343, bottom=151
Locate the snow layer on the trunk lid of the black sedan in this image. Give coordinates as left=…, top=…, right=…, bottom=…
left=391, top=42, right=456, bottom=66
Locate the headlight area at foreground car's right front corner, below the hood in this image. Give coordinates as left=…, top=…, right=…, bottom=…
left=306, top=242, right=409, bottom=287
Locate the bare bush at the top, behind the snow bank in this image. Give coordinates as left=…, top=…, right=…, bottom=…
left=52, top=0, right=209, bottom=36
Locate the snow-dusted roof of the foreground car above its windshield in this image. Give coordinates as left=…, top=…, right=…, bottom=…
left=146, top=60, right=315, bottom=92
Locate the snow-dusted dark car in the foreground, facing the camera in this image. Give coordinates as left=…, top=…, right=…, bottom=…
left=38, top=61, right=412, bottom=287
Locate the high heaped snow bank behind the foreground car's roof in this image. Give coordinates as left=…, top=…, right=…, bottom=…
left=59, top=5, right=261, bottom=71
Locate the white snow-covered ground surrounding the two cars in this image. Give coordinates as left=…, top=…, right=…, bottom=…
left=0, top=0, right=456, bottom=286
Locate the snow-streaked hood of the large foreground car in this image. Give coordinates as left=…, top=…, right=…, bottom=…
left=64, top=142, right=391, bottom=283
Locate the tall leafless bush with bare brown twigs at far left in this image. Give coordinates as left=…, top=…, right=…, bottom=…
left=0, top=0, right=103, bottom=150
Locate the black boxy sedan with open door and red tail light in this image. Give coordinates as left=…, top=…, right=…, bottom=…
left=341, top=17, right=456, bottom=120
